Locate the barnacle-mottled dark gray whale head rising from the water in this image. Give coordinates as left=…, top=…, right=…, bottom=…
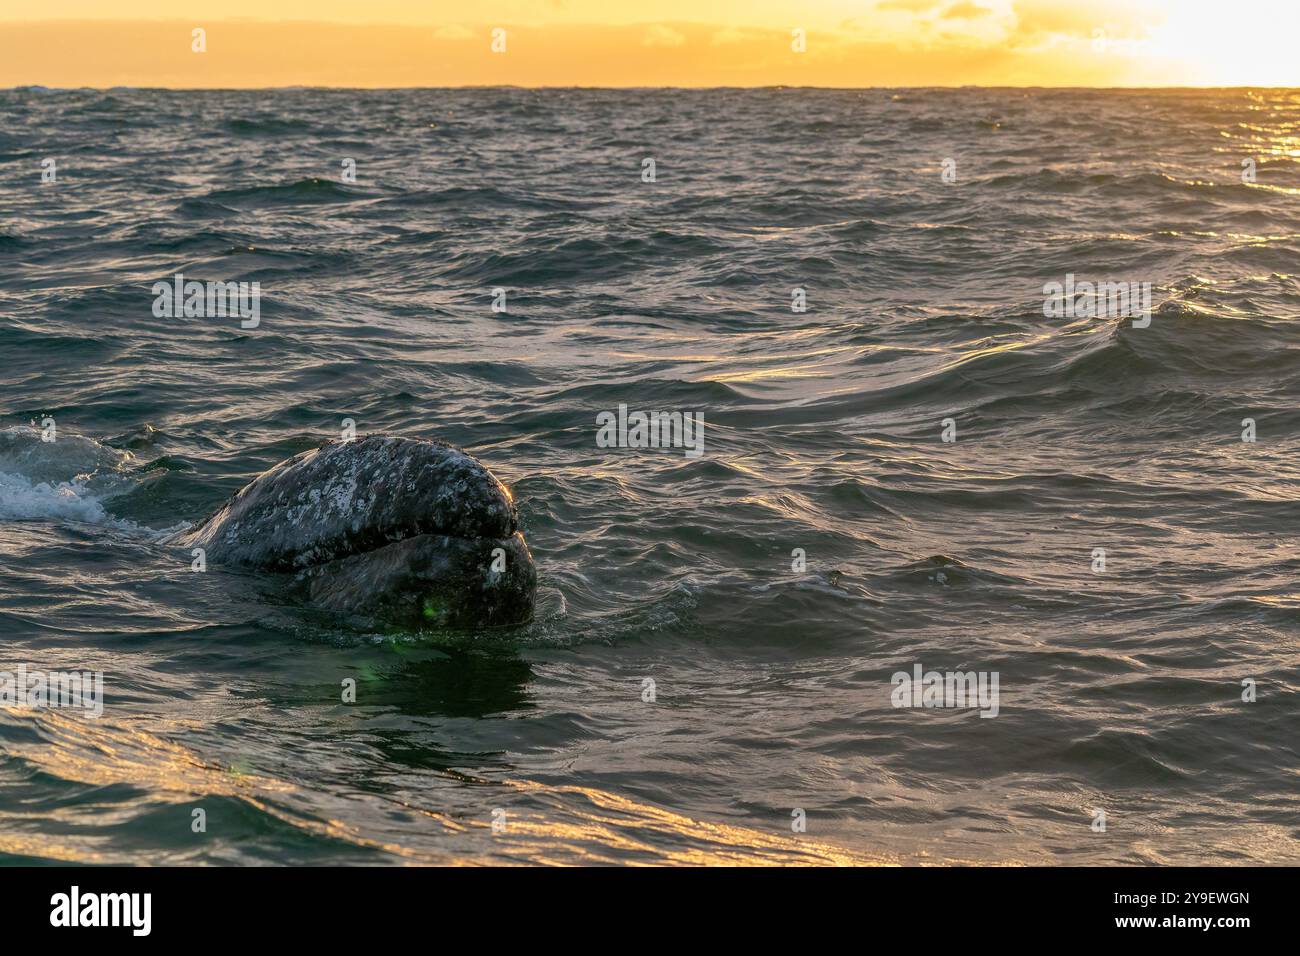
left=176, top=437, right=537, bottom=627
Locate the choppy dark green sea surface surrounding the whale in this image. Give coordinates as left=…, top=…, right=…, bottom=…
left=0, top=90, right=1300, bottom=864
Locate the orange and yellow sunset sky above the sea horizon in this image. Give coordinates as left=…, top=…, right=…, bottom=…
left=0, top=0, right=1300, bottom=87
